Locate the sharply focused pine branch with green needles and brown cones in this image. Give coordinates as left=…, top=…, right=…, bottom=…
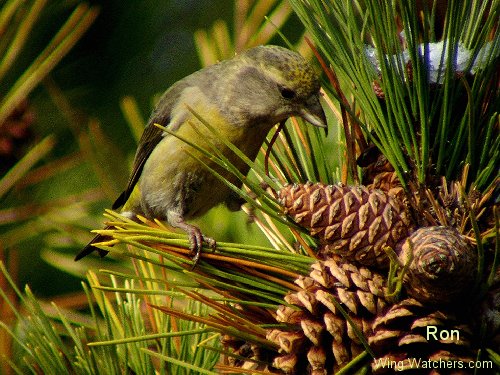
left=2, top=0, right=500, bottom=375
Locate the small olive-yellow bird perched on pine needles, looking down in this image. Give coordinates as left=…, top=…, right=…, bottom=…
left=75, top=46, right=326, bottom=262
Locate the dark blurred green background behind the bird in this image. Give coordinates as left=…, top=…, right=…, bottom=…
left=0, top=0, right=303, bottom=297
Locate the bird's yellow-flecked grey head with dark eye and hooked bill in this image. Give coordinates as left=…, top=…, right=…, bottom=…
left=221, top=46, right=326, bottom=131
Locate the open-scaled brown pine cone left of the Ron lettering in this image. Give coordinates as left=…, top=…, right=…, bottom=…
left=267, top=259, right=388, bottom=375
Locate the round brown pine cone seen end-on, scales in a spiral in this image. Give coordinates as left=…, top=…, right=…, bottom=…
left=399, top=226, right=477, bottom=304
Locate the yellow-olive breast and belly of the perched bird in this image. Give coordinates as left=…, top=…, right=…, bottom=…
left=140, top=103, right=269, bottom=219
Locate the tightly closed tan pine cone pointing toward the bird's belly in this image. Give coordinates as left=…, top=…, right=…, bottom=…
left=279, top=183, right=412, bottom=268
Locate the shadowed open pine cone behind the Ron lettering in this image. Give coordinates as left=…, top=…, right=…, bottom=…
left=368, top=298, right=476, bottom=374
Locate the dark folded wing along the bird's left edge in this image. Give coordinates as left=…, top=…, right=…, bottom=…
left=112, top=80, right=189, bottom=210
